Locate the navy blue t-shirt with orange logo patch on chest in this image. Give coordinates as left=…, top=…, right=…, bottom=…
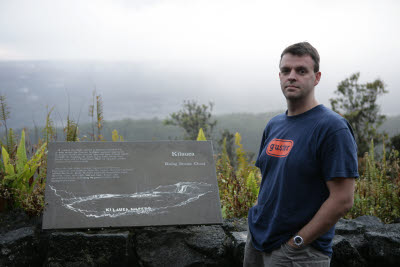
left=248, top=105, right=358, bottom=256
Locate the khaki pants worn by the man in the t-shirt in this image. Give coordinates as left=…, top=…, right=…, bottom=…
left=243, top=232, right=331, bottom=267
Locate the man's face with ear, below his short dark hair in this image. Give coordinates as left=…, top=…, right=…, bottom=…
left=279, top=54, right=321, bottom=101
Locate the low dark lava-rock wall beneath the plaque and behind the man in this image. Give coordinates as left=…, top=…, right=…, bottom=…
left=0, top=211, right=400, bottom=267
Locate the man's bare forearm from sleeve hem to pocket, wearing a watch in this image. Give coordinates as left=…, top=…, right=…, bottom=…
left=288, top=178, right=355, bottom=247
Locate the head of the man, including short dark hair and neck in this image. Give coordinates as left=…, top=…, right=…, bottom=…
left=279, top=42, right=321, bottom=103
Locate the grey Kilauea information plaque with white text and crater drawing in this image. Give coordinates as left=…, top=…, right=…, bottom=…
left=42, top=141, right=222, bottom=229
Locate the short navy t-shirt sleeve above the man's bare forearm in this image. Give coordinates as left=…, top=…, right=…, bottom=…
left=319, top=128, right=359, bottom=181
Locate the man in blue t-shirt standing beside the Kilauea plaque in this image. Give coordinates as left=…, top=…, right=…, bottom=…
left=244, top=42, right=358, bottom=266
